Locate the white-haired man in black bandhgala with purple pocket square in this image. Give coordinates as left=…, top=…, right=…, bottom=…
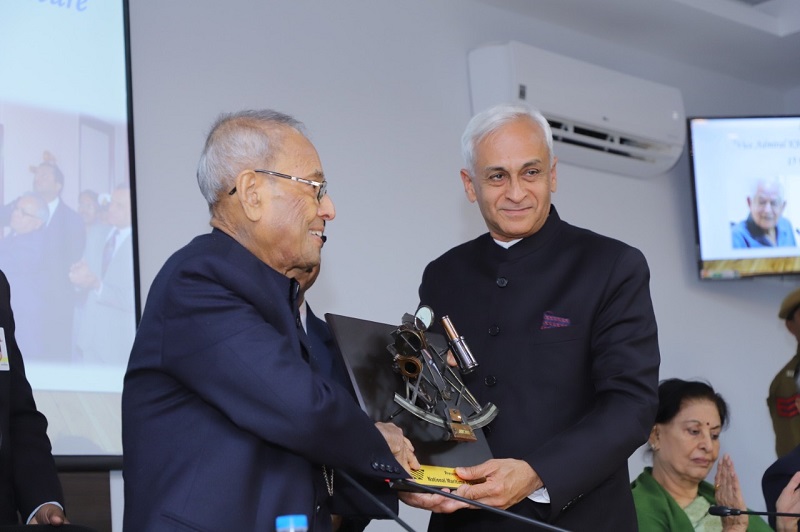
left=404, top=105, right=660, bottom=532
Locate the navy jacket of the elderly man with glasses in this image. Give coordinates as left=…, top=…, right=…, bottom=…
left=122, top=230, right=406, bottom=532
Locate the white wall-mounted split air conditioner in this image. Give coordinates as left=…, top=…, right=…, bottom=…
left=469, top=42, right=686, bottom=177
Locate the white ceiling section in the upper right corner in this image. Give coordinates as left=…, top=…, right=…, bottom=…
left=481, top=0, right=800, bottom=90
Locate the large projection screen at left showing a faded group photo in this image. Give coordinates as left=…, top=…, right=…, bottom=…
left=0, top=0, right=139, bottom=455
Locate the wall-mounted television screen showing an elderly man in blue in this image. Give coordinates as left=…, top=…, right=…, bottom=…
left=687, top=116, right=800, bottom=279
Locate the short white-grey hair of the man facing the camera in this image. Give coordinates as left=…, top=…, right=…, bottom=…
left=461, top=103, right=553, bottom=175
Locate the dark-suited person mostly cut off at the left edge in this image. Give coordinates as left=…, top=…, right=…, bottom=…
left=0, top=272, right=68, bottom=525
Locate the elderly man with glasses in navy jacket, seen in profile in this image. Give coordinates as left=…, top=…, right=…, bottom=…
left=122, top=111, right=419, bottom=532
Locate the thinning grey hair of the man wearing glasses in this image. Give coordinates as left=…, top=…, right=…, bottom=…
left=197, top=109, right=305, bottom=208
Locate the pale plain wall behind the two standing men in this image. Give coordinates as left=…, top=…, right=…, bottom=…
left=123, top=0, right=800, bottom=530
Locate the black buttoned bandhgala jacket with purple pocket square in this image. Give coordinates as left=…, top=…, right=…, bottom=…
left=419, top=207, right=660, bottom=532
